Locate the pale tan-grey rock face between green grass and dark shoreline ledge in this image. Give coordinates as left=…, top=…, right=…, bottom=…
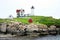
left=0, top=22, right=56, bottom=35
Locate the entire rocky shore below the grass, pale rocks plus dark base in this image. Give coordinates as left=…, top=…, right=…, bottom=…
left=0, top=21, right=60, bottom=37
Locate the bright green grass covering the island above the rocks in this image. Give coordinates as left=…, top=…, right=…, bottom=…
left=0, top=16, right=60, bottom=27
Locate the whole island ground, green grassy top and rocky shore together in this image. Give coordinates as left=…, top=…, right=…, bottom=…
left=0, top=16, right=60, bottom=37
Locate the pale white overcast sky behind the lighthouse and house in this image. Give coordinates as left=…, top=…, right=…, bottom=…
left=0, top=0, right=60, bottom=18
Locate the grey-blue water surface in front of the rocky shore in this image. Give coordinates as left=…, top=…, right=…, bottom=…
left=0, top=35, right=60, bottom=40
